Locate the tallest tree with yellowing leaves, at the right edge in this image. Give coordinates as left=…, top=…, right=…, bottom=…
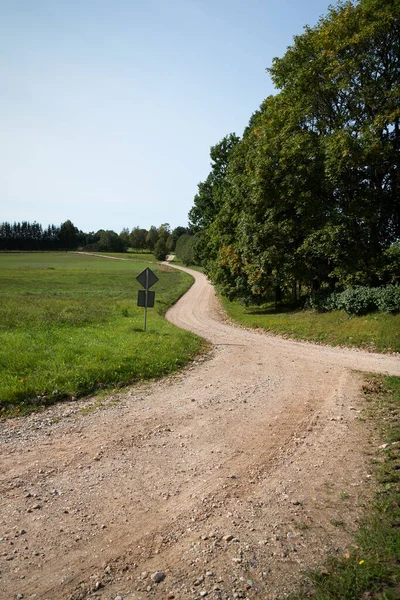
left=271, top=0, right=400, bottom=284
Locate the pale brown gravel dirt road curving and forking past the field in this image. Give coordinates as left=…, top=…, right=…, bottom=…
left=0, top=272, right=400, bottom=600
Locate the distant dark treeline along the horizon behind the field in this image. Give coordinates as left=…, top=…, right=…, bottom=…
left=0, top=220, right=190, bottom=260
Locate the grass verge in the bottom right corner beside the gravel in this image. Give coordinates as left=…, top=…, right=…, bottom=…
left=290, top=377, right=400, bottom=600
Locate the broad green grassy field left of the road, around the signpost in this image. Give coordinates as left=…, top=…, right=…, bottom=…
left=0, top=253, right=202, bottom=413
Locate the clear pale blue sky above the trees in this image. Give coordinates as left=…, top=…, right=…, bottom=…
left=0, top=0, right=329, bottom=233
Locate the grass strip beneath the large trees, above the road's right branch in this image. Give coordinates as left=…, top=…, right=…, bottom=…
left=221, top=297, right=400, bottom=352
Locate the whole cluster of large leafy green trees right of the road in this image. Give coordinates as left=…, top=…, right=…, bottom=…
left=189, top=0, right=400, bottom=303
